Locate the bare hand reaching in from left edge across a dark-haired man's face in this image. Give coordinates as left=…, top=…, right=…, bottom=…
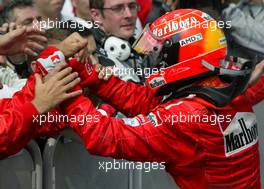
left=0, top=23, right=47, bottom=56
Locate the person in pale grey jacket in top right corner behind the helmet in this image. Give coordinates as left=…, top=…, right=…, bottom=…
left=223, top=0, right=264, bottom=61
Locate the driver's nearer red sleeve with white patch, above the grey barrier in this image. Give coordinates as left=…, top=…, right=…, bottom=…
left=64, top=96, right=176, bottom=162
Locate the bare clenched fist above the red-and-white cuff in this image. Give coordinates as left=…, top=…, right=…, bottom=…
left=57, top=32, right=88, bottom=58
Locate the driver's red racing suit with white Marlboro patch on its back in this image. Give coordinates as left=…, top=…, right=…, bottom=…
left=64, top=59, right=264, bottom=189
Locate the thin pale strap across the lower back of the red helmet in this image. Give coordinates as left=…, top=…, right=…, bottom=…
left=202, top=60, right=252, bottom=76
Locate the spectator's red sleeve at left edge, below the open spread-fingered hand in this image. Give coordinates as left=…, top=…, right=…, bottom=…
left=0, top=100, right=38, bottom=159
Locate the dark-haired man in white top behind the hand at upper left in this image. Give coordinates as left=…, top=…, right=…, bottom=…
left=0, top=0, right=45, bottom=98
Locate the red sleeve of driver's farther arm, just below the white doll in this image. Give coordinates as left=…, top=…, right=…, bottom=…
left=67, top=61, right=162, bottom=117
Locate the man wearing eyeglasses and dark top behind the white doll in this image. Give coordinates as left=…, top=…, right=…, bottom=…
left=90, top=0, right=149, bottom=83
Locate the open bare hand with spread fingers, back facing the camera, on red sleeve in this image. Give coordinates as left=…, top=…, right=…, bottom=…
left=32, top=64, right=82, bottom=114
